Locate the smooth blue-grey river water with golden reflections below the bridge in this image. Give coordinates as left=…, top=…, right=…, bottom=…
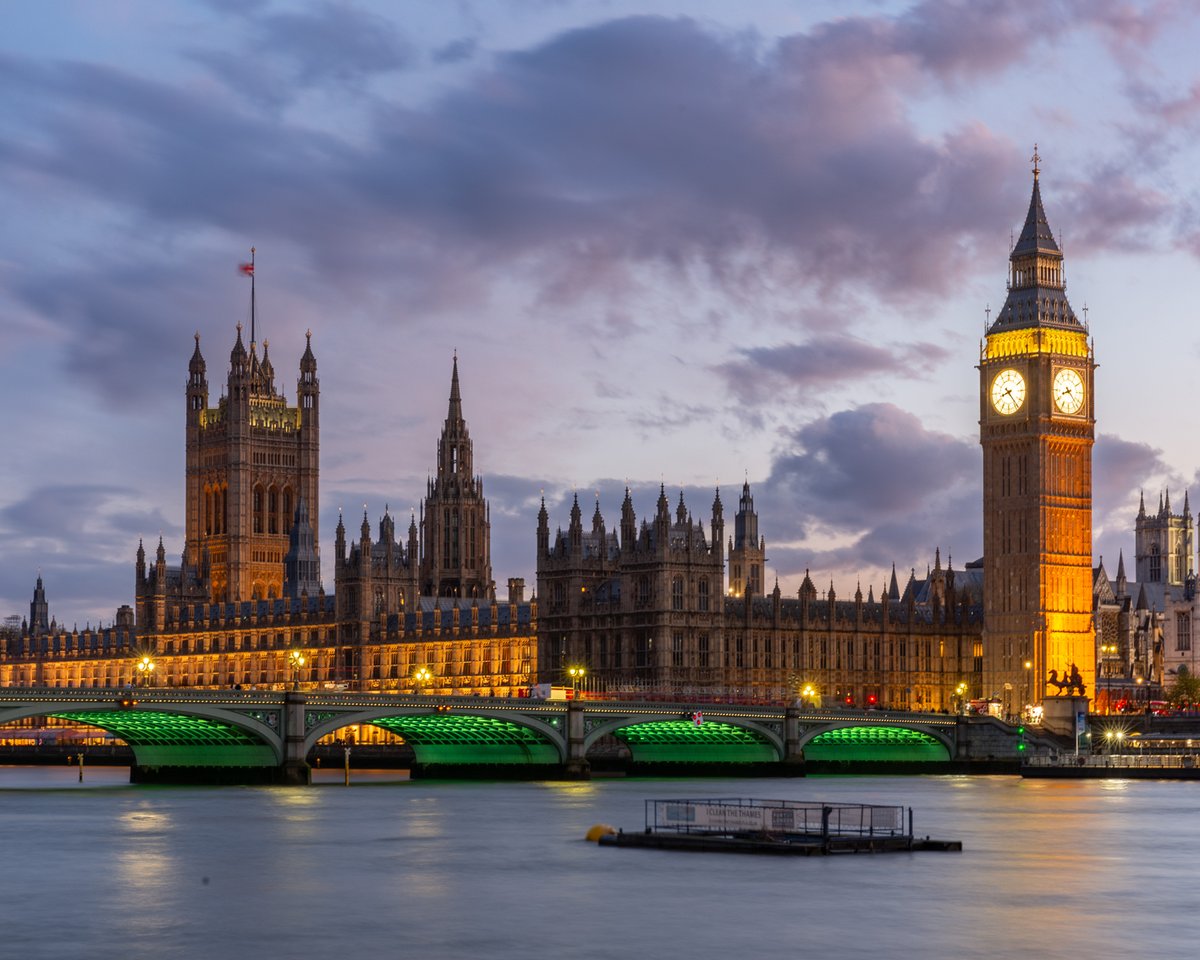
left=0, top=767, right=1200, bottom=960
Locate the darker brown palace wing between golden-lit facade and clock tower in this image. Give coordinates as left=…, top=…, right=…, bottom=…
left=538, top=475, right=982, bottom=710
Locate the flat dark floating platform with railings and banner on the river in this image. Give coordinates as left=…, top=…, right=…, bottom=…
left=593, top=797, right=962, bottom=857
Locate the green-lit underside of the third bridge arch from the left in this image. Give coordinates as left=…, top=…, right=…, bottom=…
left=612, top=720, right=779, bottom=763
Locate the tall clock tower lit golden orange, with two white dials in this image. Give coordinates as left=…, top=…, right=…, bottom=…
left=979, top=149, right=1096, bottom=713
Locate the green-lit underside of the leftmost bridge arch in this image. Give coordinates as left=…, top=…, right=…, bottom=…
left=47, top=710, right=278, bottom=767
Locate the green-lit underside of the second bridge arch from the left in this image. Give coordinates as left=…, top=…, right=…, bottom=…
left=362, top=713, right=560, bottom=764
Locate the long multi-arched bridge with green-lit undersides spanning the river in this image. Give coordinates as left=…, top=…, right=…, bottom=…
left=0, top=688, right=1036, bottom=784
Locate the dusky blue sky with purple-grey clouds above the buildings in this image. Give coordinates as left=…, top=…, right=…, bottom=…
left=0, top=0, right=1200, bottom=626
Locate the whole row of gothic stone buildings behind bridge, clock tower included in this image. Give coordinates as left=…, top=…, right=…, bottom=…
left=0, top=161, right=1180, bottom=714
